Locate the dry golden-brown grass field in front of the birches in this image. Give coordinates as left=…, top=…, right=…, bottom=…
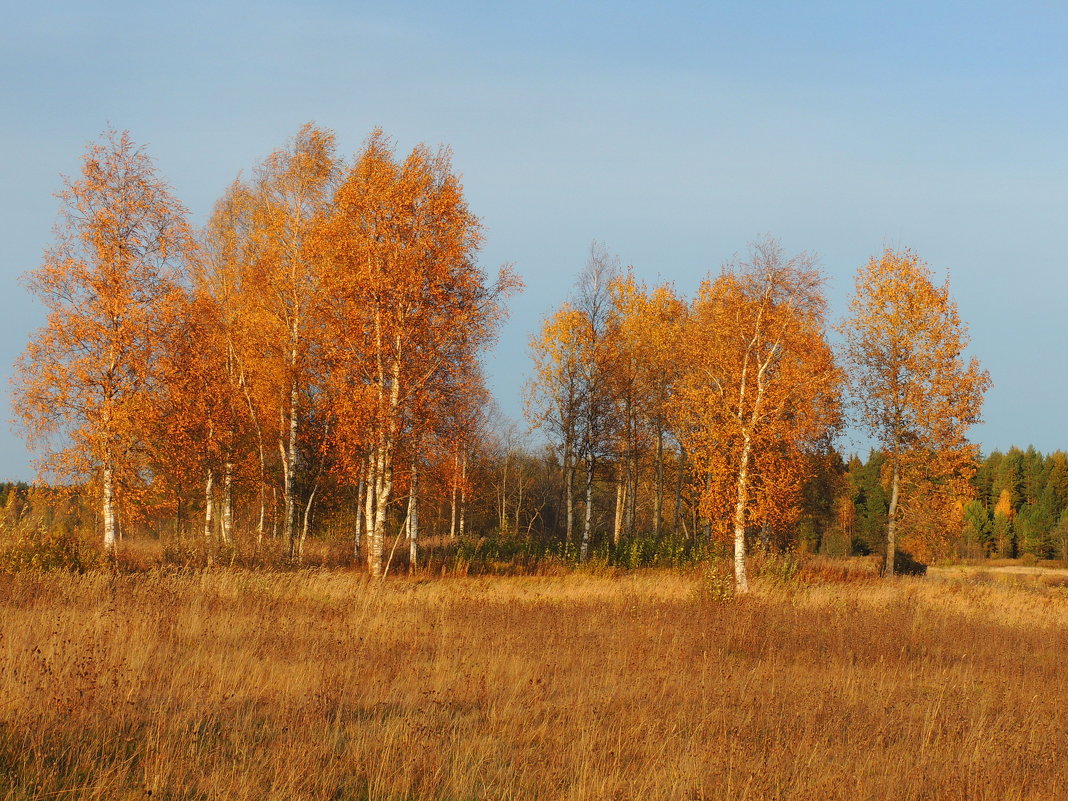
left=0, top=569, right=1068, bottom=801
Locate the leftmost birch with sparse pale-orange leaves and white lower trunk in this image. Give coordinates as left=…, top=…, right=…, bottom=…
left=13, top=131, right=192, bottom=552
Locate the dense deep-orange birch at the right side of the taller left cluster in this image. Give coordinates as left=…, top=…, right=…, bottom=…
left=321, top=131, right=518, bottom=576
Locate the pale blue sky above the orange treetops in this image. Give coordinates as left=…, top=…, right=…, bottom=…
left=0, top=0, right=1068, bottom=478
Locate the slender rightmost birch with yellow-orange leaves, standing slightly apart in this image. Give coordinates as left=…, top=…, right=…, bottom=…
left=839, top=250, right=990, bottom=576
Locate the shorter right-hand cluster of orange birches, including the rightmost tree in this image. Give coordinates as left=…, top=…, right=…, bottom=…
left=529, top=238, right=989, bottom=590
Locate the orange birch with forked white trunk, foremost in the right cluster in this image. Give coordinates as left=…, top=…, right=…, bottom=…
left=672, top=239, right=841, bottom=592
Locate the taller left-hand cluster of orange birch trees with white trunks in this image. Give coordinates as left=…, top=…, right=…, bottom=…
left=14, top=125, right=519, bottom=575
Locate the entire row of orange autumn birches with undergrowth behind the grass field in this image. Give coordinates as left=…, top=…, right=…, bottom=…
left=12, top=124, right=1033, bottom=593
